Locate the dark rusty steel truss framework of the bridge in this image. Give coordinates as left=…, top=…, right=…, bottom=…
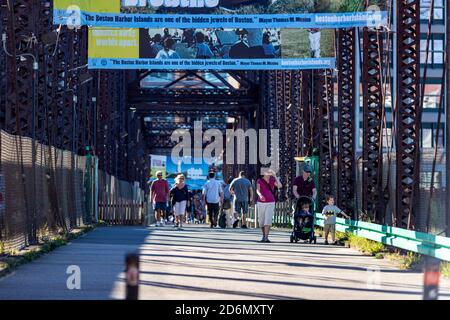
left=0, top=0, right=446, bottom=235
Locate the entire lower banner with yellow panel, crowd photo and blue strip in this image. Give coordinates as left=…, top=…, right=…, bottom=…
left=89, top=28, right=335, bottom=70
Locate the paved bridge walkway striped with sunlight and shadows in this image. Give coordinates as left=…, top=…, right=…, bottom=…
left=0, top=226, right=450, bottom=299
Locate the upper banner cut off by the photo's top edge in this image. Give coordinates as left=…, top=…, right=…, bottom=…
left=53, top=0, right=387, bottom=28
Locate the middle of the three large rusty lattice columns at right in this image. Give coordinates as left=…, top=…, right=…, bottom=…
left=362, top=28, right=384, bottom=223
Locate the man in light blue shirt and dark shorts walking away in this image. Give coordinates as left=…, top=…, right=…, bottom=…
left=203, top=172, right=223, bottom=228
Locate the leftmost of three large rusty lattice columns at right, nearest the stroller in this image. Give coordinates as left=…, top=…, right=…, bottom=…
left=337, top=29, right=356, bottom=218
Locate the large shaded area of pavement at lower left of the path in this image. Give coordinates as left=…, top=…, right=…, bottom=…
left=0, top=227, right=149, bottom=300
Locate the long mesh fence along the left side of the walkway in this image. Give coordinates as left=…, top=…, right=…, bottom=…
left=0, top=131, right=144, bottom=254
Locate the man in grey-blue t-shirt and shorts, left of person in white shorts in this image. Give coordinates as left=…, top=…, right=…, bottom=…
left=230, top=171, right=253, bottom=229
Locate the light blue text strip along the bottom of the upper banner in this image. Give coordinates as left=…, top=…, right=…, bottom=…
left=53, top=10, right=388, bottom=29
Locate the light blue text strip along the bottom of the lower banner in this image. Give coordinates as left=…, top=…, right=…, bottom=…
left=88, top=58, right=336, bottom=70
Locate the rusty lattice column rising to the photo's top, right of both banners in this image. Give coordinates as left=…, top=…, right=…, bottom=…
left=395, top=0, right=421, bottom=229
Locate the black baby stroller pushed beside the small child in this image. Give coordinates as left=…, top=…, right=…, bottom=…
left=291, top=196, right=317, bottom=244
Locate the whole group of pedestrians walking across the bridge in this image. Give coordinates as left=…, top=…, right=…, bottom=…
left=151, top=164, right=350, bottom=244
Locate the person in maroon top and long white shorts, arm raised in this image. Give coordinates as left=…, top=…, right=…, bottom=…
left=256, top=169, right=282, bottom=242
